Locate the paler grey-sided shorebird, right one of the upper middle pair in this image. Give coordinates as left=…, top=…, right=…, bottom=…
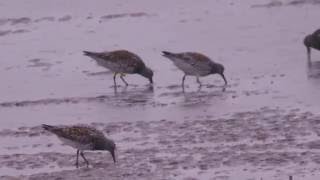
left=162, top=51, right=227, bottom=87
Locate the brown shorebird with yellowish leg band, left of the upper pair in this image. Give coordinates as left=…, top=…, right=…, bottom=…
left=83, top=50, right=153, bottom=86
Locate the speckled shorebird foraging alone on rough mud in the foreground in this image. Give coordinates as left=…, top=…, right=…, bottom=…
left=42, top=124, right=116, bottom=168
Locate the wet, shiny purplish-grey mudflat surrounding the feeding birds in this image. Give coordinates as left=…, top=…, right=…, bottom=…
left=0, top=0, right=320, bottom=180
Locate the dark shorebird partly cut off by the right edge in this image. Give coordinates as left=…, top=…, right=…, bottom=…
left=303, top=29, right=320, bottom=61
